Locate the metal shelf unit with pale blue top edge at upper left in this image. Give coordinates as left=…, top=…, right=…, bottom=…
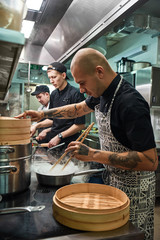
left=0, top=28, right=25, bottom=102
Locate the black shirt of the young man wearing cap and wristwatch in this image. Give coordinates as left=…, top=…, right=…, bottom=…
left=49, top=83, right=85, bottom=140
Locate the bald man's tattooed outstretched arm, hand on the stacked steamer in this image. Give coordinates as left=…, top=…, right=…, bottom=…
left=15, top=101, right=93, bottom=121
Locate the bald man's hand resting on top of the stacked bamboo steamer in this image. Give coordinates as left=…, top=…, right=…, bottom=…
left=15, top=110, right=44, bottom=122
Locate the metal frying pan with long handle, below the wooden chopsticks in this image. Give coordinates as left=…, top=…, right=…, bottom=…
left=35, top=168, right=105, bottom=186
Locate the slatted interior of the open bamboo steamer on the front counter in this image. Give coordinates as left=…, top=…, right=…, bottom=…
left=55, top=183, right=128, bottom=213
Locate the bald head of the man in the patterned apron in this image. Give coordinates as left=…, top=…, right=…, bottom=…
left=71, top=48, right=117, bottom=97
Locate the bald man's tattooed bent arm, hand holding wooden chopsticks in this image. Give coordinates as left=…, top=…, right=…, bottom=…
left=66, top=142, right=158, bottom=171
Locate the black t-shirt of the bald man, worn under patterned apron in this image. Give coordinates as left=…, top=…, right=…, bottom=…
left=86, top=75, right=156, bottom=151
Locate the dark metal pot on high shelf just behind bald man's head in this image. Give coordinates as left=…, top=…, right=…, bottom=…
left=117, top=57, right=135, bottom=73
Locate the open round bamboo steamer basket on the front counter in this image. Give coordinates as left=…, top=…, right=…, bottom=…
left=53, top=183, right=130, bottom=231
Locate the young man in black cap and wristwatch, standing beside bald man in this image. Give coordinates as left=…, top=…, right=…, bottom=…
left=29, top=62, right=85, bottom=147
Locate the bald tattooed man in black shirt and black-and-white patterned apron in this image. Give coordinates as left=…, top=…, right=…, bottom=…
left=17, top=48, right=158, bottom=240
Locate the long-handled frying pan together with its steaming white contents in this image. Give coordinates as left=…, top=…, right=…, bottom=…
left=34, top=166, right=105, bottom=186
